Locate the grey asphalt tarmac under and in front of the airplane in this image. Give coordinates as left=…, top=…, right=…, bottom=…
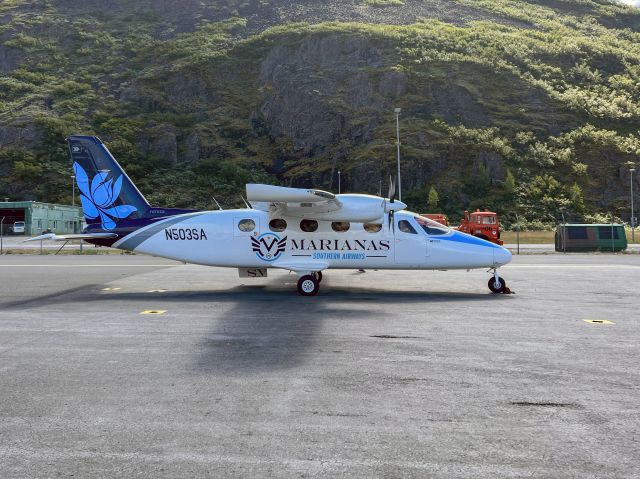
left=0, top=254, right=640, bottom=478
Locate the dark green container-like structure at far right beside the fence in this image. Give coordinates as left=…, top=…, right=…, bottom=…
left=555, top=224, right=627, bottom=253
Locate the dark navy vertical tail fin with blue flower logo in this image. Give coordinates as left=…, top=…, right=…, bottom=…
left=67, top=135, right=151, bottom=231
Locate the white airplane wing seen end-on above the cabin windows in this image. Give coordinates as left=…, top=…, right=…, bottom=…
left=247, top=184, right=342, bottom=216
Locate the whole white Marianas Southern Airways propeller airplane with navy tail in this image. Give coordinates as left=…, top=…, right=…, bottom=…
left=27, top=136, right=511, bottom=296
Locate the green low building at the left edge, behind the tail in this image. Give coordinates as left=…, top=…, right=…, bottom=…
left=0, top=201, right=84, bottom=236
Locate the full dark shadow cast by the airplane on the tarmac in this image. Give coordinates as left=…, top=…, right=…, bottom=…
left=5, top=281, right=510, bottom=376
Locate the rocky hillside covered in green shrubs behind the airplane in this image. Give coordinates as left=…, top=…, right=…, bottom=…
left=0, top=0, right=640, bottom=226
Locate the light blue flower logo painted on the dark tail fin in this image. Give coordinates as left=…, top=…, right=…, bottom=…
left=73, top=163, right=138, bottom=230
